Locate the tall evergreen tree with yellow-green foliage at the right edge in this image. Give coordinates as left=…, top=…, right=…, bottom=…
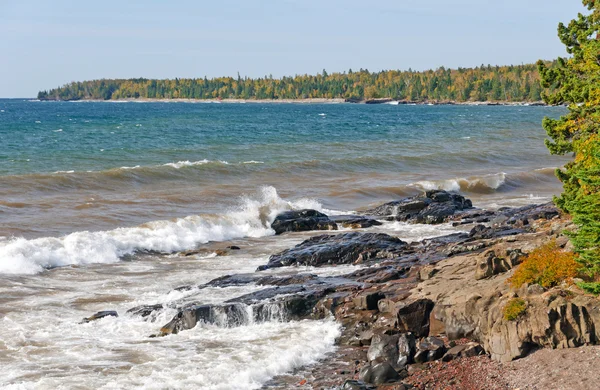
left=538, top=0, right=600, bottom=276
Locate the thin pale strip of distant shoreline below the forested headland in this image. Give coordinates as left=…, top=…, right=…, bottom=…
left=40, top=98, right=548, bottom=106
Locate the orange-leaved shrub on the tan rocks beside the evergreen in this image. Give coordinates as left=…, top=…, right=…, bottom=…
left=508, top=240, right=579, bottom=288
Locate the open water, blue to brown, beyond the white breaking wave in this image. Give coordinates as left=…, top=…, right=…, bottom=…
left=0, top=100, right=567, bottom=237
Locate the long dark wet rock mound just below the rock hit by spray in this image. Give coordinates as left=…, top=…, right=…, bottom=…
left=258, top=232, right=407, bottom=271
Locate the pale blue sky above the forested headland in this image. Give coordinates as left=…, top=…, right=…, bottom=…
left=0, top=0, right=586, bottom=98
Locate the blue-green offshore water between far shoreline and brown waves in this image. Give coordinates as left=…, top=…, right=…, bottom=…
left=0, top=100, right=564, bottom=175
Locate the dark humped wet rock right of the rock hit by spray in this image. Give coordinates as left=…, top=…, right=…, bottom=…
left=363, top=190, right=473, bottom=224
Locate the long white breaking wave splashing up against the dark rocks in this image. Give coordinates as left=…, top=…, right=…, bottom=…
left=0, top=187, right=330, bottom=274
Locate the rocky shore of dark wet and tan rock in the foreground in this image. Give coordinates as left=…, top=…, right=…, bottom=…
left=85, top=191, right=600, bottom=389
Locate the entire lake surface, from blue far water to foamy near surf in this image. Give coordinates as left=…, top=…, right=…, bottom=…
left=0, top=100, right=567, bottom=389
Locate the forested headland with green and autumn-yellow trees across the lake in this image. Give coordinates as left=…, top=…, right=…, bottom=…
left=38, top=63, right=552, bottom=102
